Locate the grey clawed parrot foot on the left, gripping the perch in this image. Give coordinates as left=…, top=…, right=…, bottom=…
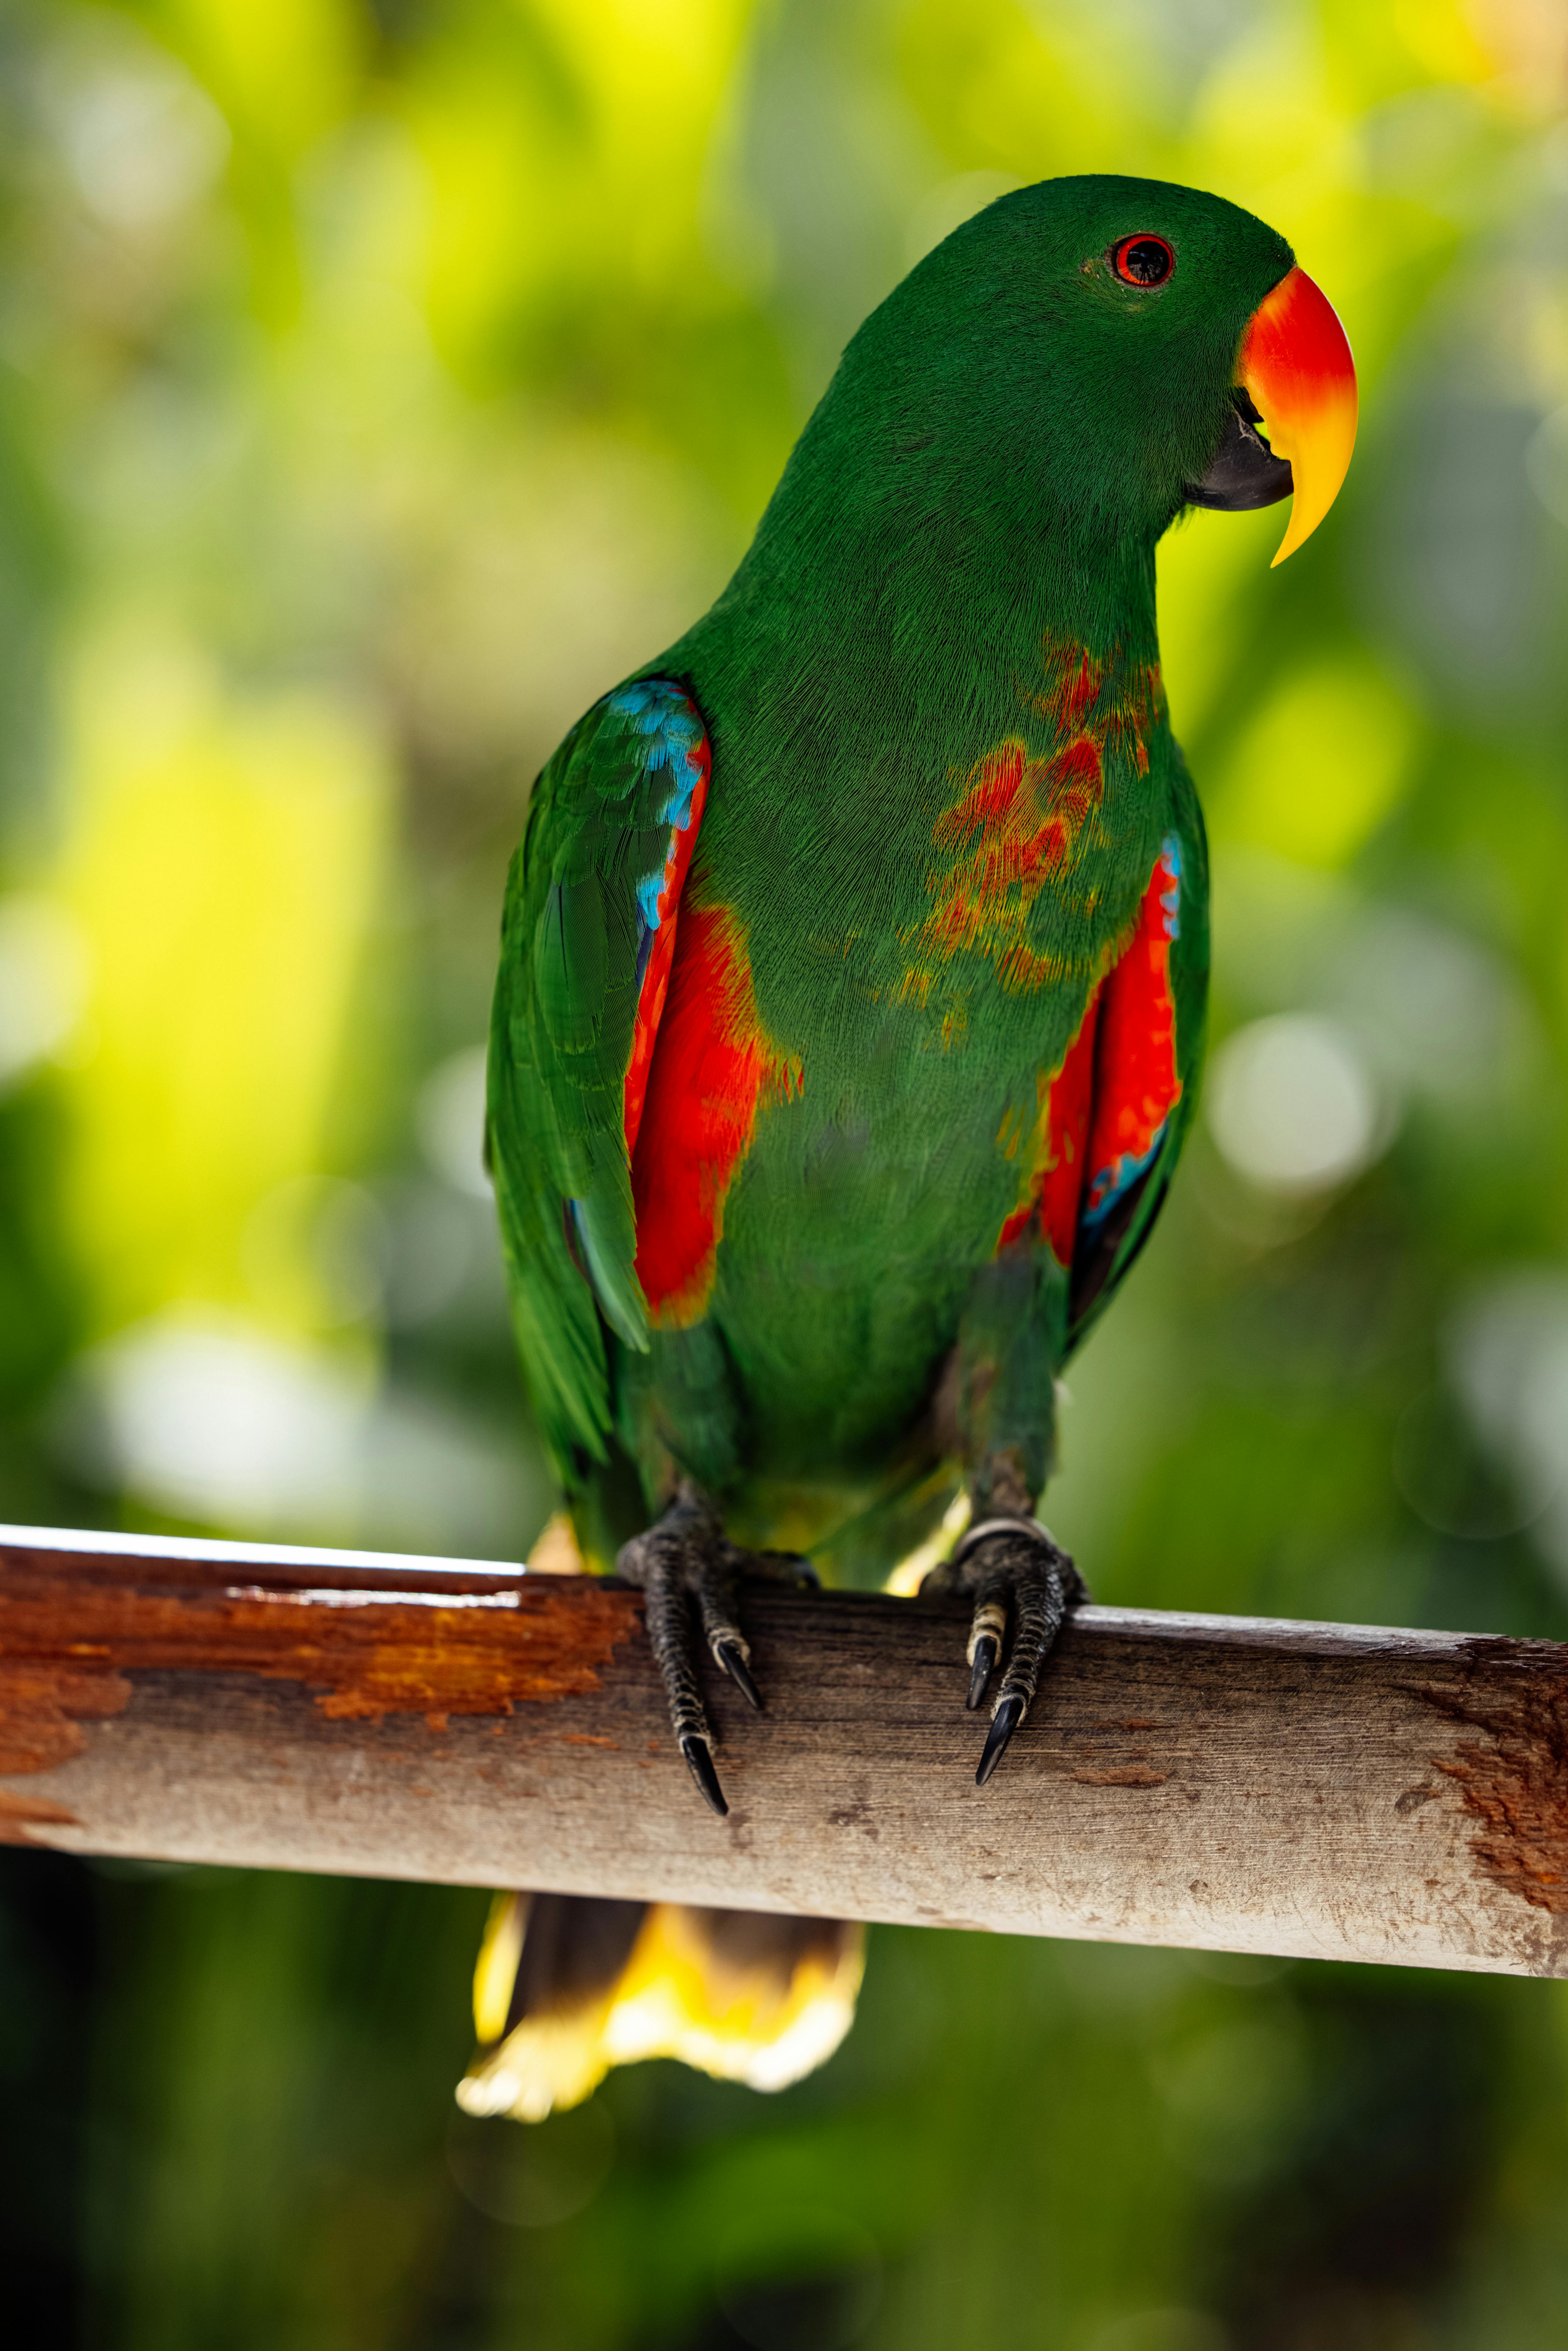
left=616, top=1484, right=816, bottom=1815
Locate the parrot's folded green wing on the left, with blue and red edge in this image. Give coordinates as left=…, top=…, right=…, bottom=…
left=486, top=677, right=708, bottom=1491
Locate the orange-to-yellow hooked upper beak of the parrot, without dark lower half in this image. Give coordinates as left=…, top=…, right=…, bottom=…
left=1236, top=270, right=1356, bottom=564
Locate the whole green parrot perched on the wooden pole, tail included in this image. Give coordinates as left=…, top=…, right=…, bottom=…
left=461, top=176, right=1356, bottom=2116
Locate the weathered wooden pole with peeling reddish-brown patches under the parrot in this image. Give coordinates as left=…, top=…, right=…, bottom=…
left=0, top=1528, right=1568, bottom=1975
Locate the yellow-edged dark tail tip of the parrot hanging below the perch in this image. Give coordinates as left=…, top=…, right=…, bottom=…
left=458, top=1895, right=865, bottom=2123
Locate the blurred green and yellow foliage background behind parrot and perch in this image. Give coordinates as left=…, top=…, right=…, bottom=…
left=0, top=0, right=1568, bottom=2351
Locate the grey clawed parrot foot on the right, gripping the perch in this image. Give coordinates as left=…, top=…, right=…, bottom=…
left=921, top=1516, right=1089, bottom=1787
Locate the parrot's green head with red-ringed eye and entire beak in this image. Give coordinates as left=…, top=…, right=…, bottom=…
left=846, top=176, right=1356, bottom=562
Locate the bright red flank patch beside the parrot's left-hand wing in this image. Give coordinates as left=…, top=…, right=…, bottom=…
left=632, top=905, right=804, bottom=1331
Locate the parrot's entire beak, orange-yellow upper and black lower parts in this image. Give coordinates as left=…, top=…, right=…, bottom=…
left=1187, top=270, right=1356, bottom=564
